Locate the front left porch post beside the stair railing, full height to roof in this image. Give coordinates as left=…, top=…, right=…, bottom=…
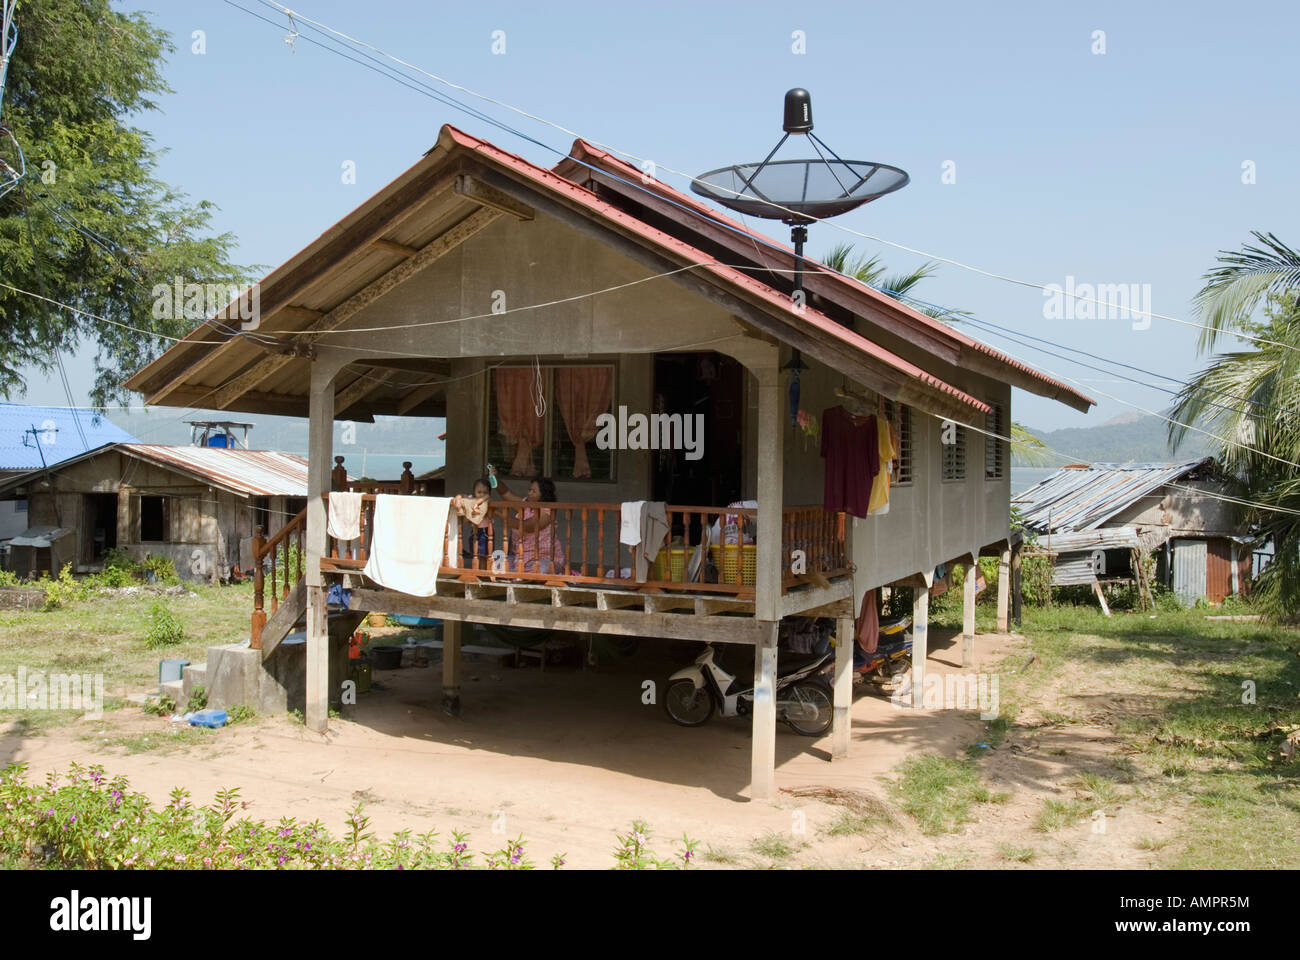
left=304, top=362, right=338, bottom=734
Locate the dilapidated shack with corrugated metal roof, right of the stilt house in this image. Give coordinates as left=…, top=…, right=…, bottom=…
left=1011, top=458, right=1253, bottom=605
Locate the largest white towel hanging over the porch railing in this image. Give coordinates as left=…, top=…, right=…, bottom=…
left=365, top=493, right=451, bottom=597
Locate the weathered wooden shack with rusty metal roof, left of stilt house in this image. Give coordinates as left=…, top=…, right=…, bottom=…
left=0, top=444, right=307, bottom=580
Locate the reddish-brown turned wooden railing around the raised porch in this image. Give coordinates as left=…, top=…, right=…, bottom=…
left=313, top=494, right=849, bottom=596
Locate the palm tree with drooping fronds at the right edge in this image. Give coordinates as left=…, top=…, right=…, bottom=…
left=1169, top=232, right=1300, bottom=615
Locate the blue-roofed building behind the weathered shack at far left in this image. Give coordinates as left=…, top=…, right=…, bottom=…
left=0, top=403, right=135, bottom=544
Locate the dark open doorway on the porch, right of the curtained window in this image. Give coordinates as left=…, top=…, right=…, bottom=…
left=650, top=353, right=745, bottom=506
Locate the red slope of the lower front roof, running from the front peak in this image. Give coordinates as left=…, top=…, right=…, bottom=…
left=442, top=124, right=991, bottom=414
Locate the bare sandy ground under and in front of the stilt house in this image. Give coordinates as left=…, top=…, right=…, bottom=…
left=0, top=633, right=1180, bottom=868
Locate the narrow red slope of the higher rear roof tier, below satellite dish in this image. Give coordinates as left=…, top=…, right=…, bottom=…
left=556, top=138, right=1096, bottom=405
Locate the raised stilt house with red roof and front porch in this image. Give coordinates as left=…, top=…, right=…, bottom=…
left=127, top=126, right=1092, bottom=797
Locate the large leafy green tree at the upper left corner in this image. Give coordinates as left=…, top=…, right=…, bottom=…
left=0, top=0, right=248, bottom=405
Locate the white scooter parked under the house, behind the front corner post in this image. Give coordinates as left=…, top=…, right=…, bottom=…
left=663, top=644, right=835, bottom=736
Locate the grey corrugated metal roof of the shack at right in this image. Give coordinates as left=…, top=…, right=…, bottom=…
left=1011, top=458, right=1214, bottom=533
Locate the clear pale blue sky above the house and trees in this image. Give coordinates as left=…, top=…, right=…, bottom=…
left=20, top=0, right=1300, bottom=429
